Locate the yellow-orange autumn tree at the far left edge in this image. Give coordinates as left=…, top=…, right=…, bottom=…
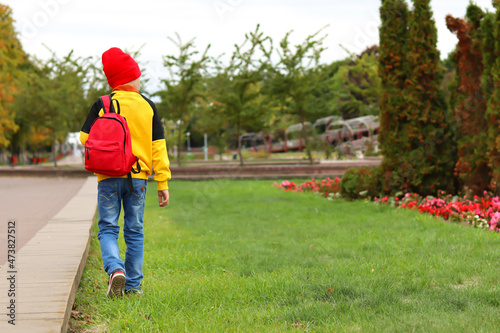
left=0, top=4, right=27, bottom=148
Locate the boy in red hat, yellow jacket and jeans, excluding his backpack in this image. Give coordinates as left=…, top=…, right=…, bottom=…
left=80, top=47, right=171, bottom=298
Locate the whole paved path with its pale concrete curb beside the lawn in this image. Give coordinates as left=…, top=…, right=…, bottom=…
left=0, top=176, right=97, bottom=333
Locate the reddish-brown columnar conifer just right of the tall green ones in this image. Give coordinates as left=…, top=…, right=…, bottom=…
left=446, top=4, right=491, bottom=194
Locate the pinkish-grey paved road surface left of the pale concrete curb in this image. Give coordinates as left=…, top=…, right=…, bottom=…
left=0, top=177, right=87, bottom=266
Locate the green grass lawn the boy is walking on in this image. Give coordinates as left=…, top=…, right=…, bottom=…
left=70, top=180, right=500, bottom=332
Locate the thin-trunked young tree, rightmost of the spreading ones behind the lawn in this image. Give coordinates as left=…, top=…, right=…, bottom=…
left=269, top=29, right=327, bottom=163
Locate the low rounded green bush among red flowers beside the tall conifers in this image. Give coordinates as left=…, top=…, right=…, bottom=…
left=340, top=166, right=383, bottom=199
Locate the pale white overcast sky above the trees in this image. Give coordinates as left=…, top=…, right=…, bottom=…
left=0, top=0, right=494, bottom=90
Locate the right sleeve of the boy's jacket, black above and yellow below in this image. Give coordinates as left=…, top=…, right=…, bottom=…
left=150, top=98, right=172, bottom=191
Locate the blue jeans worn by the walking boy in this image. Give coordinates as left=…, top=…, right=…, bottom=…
left=97, top=178, right=147, bottom=290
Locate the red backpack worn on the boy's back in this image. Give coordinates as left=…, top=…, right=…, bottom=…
left=85, top=95, right=141, bottom=179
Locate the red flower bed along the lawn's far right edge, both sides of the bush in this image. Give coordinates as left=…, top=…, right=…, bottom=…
left=273, top=177, right=500, bottom=232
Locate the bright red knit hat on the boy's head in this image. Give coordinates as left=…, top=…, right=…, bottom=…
left=102, top=47, right=141, bottom=89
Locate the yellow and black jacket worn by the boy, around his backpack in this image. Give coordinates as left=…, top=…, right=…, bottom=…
left=80, top=85, right=171, bottom=191
